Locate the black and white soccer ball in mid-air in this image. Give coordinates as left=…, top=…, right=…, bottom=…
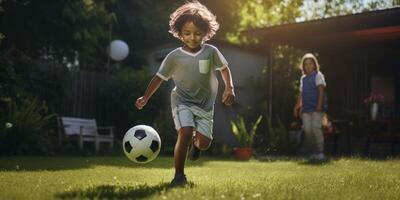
left=122, top=125, right=161, bottom=163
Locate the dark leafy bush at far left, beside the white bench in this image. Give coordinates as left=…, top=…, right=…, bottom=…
left=0, top=96, right=55, bottom=155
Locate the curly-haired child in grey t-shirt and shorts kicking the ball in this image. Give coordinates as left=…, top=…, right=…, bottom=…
left=135, top=1, right=235, bottom=185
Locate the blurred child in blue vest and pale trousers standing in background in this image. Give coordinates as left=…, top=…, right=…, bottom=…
left=293, top=53, right=326, bottom=161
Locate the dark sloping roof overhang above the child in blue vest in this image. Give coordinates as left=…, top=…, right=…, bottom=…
left=246, top=7, right=400, bottom=49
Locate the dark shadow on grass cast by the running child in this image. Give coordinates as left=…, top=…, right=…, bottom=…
left=55, top=183, right=194, bottom=199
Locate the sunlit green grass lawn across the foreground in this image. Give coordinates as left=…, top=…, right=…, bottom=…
left=0, top=157, right=400, bottom=200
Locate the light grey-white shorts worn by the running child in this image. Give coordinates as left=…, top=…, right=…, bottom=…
left=172, top=105, right=214, bottom=139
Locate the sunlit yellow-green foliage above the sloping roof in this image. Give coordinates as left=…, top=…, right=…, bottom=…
left=226, top=0, right=400, bottom=43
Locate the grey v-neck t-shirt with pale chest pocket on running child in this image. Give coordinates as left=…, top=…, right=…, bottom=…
left=157, top=44, right=228, bottom=111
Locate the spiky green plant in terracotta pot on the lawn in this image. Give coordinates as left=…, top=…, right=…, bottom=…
left=231, top=115, right=262, bottom=160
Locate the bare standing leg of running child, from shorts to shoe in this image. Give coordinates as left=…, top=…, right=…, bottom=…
left=174, top=126, right=193, bottom=175
